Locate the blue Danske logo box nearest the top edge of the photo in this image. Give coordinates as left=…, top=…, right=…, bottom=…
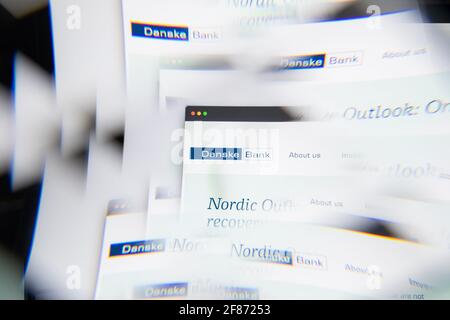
left=131, top=22, right=189, bottom=41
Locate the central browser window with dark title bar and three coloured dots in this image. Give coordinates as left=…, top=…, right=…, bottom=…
left=181, top=106, right=449, bottom=231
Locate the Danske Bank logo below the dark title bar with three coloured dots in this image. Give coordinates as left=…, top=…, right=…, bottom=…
left=189, top=147, right=273, bottom=160
